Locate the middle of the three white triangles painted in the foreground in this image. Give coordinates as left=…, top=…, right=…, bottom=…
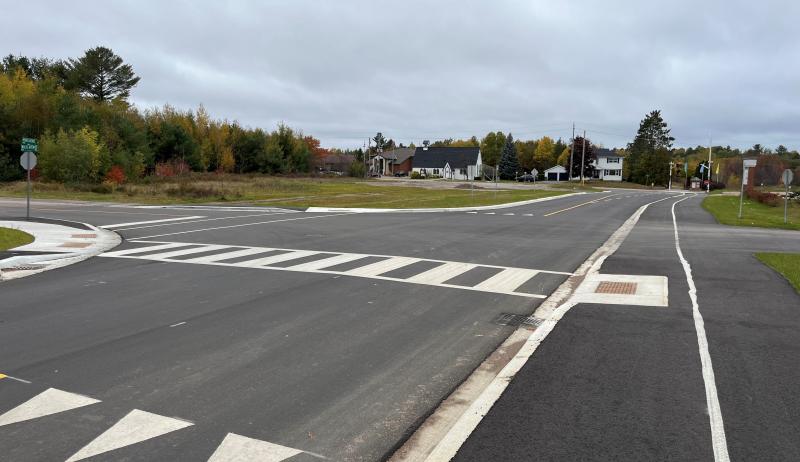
left=66, top=409, right=194, bottom=462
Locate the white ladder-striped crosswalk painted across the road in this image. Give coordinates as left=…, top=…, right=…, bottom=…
left=101, top=241, right=571, bottom=298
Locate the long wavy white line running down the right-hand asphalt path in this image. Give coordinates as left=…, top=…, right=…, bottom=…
left=672, top=197, right=730, bottom=462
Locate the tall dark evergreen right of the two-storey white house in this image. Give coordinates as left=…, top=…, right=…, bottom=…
left=627, top=110, right=675, bottom=184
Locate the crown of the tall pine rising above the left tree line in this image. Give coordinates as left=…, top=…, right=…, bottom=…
left=67, top=47, right=139, bottom=101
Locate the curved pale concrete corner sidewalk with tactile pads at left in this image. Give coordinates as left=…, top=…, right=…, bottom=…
left=0, top=218, right=122, bottom=281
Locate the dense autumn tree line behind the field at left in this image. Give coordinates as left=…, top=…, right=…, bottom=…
left=0, top=47, right=328, bottom=182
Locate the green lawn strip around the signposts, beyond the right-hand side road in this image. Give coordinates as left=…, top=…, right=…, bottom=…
left=703, top=195, right=800, bottom=230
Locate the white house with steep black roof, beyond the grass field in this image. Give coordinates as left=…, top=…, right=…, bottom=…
left=411, top=147, right=483, bottom=180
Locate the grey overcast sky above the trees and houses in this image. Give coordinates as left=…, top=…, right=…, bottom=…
left=0, top=0, right=800, bottom=149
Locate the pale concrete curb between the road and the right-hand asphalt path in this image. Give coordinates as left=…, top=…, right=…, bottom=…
left=416, top=195, right=676, bottom=462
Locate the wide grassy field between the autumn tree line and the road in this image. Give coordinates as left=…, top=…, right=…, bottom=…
left=0, top=175, right=566, bottom=208
